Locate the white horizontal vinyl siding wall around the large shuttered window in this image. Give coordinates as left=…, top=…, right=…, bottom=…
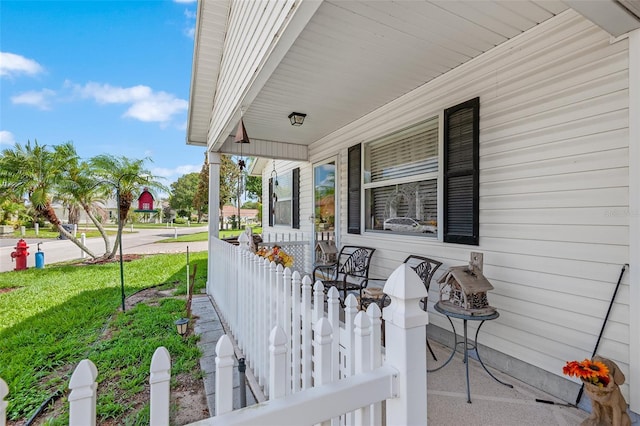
left=308, top=11, right=633, bottom=402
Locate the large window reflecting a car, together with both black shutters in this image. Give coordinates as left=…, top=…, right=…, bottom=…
left=347, top=98, right=480, bottom=245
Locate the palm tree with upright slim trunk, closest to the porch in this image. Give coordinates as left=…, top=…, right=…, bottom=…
left=89, top=154, right=168, bottom=259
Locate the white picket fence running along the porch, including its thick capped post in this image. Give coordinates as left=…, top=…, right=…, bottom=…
left=206, top=241, right=428, bottom=425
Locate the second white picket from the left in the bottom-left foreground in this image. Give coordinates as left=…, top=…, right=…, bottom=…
left=69, top=359, right=98, bottom=426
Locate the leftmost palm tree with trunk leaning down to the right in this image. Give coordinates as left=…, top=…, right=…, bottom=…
left=0, top=140, right=96, bottom=258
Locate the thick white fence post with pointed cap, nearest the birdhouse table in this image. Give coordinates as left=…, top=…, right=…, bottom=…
left=382, top=264, right=429, bottom=425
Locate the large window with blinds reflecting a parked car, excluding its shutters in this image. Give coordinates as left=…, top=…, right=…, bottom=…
left=363, top=117, right=438, bottom=236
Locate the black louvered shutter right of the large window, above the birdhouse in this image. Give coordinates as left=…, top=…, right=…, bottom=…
left=443, top=98, right=480, bottom=245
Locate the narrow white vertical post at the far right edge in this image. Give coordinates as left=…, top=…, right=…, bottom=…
left=627, top=30, right=640, bottom=413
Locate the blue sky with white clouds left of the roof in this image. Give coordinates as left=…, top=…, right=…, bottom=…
left=0, top=0, right=204, bottom=185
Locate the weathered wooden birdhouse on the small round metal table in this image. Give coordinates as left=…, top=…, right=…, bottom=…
left=438, top=252, right=496, bottom=315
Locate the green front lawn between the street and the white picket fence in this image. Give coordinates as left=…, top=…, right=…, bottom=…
left=0, top=252, right=207, bottom=425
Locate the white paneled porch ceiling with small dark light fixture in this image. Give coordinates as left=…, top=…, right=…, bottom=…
left=188, top=0, right=636, bottom=159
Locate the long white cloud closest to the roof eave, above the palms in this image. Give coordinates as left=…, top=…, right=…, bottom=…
left=74, top=82, right=189, bottom=123
